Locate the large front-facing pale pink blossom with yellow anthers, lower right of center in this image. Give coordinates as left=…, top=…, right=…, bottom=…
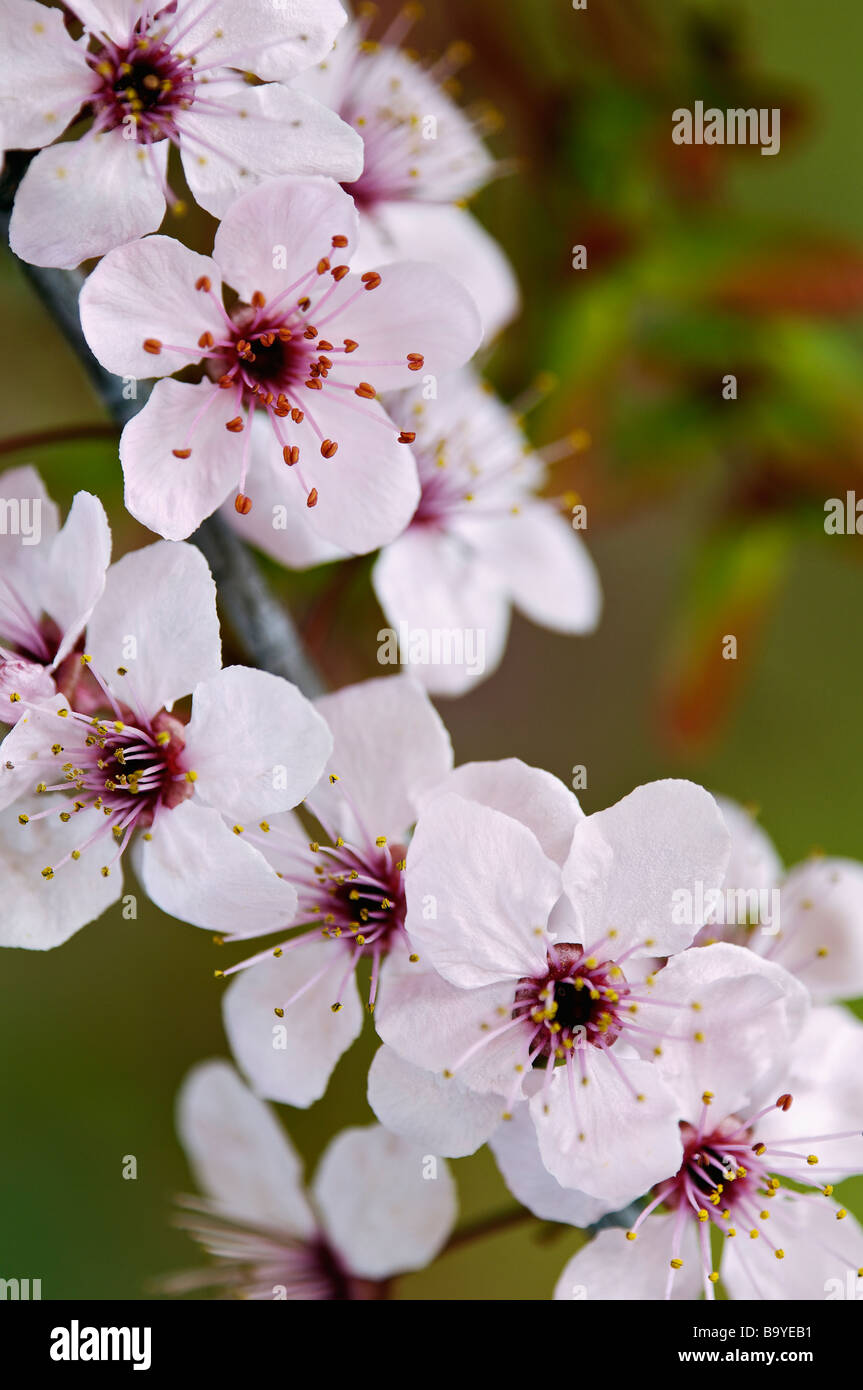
left=372, top=760, right=806, bottom=1207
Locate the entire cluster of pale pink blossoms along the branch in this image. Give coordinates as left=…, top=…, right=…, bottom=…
left=0, top=0, right=863, bottom=1298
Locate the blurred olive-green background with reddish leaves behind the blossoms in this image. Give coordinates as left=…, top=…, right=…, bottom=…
left=0, top=0, right=863, bottom=1300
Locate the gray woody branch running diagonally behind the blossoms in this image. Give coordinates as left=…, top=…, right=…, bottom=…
left=0, top=194, right=324, bottom=696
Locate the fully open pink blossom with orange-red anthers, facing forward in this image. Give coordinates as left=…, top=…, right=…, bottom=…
left=81, top=178, right=479, bottom=552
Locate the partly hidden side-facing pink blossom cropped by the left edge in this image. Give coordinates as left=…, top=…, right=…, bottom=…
left=0, top=467, right=111, bottom=723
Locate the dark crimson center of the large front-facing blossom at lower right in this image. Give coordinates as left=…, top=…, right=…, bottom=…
left=513, top=942, right=630, bottom=1066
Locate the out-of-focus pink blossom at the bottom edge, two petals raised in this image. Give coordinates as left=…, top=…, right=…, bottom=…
left=165, top=1062, right=456, bottom=1300
